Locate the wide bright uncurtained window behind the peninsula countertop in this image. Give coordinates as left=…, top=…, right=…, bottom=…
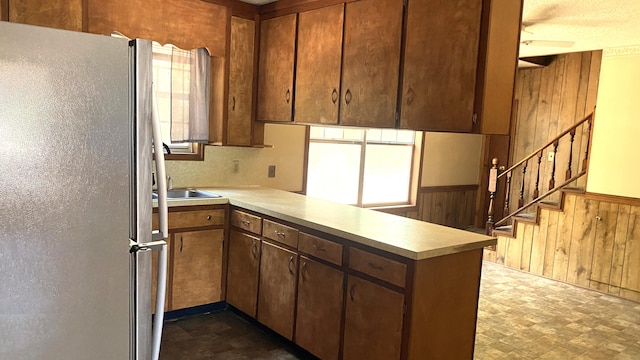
left=307, top=126, right=422, bottom=207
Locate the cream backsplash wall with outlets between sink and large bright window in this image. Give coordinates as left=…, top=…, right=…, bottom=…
left=166, top=124, right=305, bottom=191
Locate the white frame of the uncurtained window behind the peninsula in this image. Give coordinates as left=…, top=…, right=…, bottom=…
left=302, top=125, right=424, bottom=211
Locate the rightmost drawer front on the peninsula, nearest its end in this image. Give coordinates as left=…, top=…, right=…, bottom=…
left=349, top=247, right=407, bottom=287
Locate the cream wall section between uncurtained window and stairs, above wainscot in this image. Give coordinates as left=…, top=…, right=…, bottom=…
left=422, top=132, right=482, bottom=187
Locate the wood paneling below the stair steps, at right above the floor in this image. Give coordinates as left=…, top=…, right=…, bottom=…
left=485, top=194, right=640, bottom=301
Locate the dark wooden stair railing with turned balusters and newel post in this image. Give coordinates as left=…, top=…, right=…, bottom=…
left=486, top=112, right=595, bottom=235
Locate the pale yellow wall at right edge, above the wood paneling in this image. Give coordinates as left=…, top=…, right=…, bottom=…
left=587, top=46, right=640, bottom=198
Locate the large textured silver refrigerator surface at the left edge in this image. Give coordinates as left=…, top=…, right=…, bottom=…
left=0, top=22, right=133, bottom=360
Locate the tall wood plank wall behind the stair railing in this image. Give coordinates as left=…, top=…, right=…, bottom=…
left=509, top=51, right=602, bottom=211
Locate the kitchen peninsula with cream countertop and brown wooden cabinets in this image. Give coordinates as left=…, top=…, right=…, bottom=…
left=155, top=187, right=496, bottom=360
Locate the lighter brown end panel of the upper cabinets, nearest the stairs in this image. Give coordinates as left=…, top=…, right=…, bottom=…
left=476, top=0, right=523, bottom=135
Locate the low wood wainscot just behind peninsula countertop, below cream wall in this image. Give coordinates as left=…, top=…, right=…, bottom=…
left=384, top=185, right=478, bottom=229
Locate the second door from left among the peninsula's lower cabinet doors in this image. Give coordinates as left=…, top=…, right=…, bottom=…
left=257, top=241, right=298, bottom=340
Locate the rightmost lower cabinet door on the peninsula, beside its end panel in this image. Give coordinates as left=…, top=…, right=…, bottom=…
left=343, top=275, right=404, bottom=360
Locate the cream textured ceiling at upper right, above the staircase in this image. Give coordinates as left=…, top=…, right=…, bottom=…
left=242, top=0, right=640, bottom=57
